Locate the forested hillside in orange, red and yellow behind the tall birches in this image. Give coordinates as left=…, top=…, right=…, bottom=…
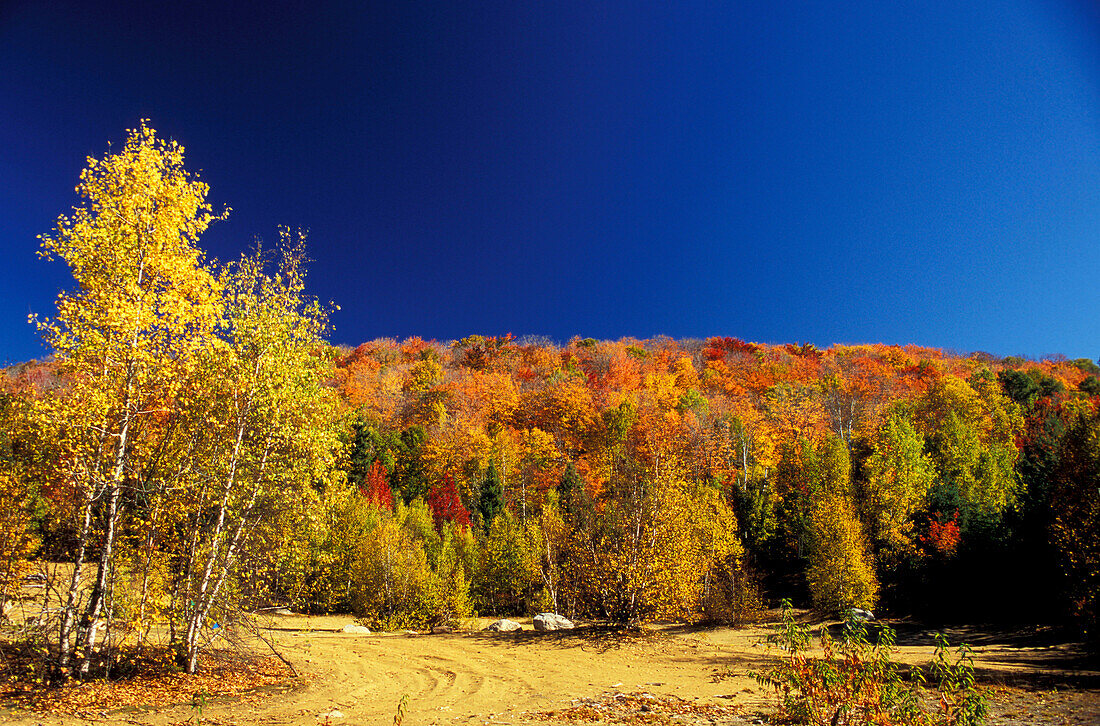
left=3, top=336, right=1100, bottom=651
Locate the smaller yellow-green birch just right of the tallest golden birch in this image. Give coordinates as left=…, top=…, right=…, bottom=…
left=173, top=235, right=340, bottom=672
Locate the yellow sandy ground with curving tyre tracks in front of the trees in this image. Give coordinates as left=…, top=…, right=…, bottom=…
left=0, top=616, right=1100, bottom=726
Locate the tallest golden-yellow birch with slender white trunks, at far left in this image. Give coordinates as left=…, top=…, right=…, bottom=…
left=36, top=122, right=219, bottom=675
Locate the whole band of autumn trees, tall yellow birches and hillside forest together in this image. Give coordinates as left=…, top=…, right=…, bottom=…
left=0, top=127, right=1100, bottom=678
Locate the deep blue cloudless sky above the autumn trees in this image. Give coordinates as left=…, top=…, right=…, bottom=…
left=0, top=0, right=1100, bottom=363
